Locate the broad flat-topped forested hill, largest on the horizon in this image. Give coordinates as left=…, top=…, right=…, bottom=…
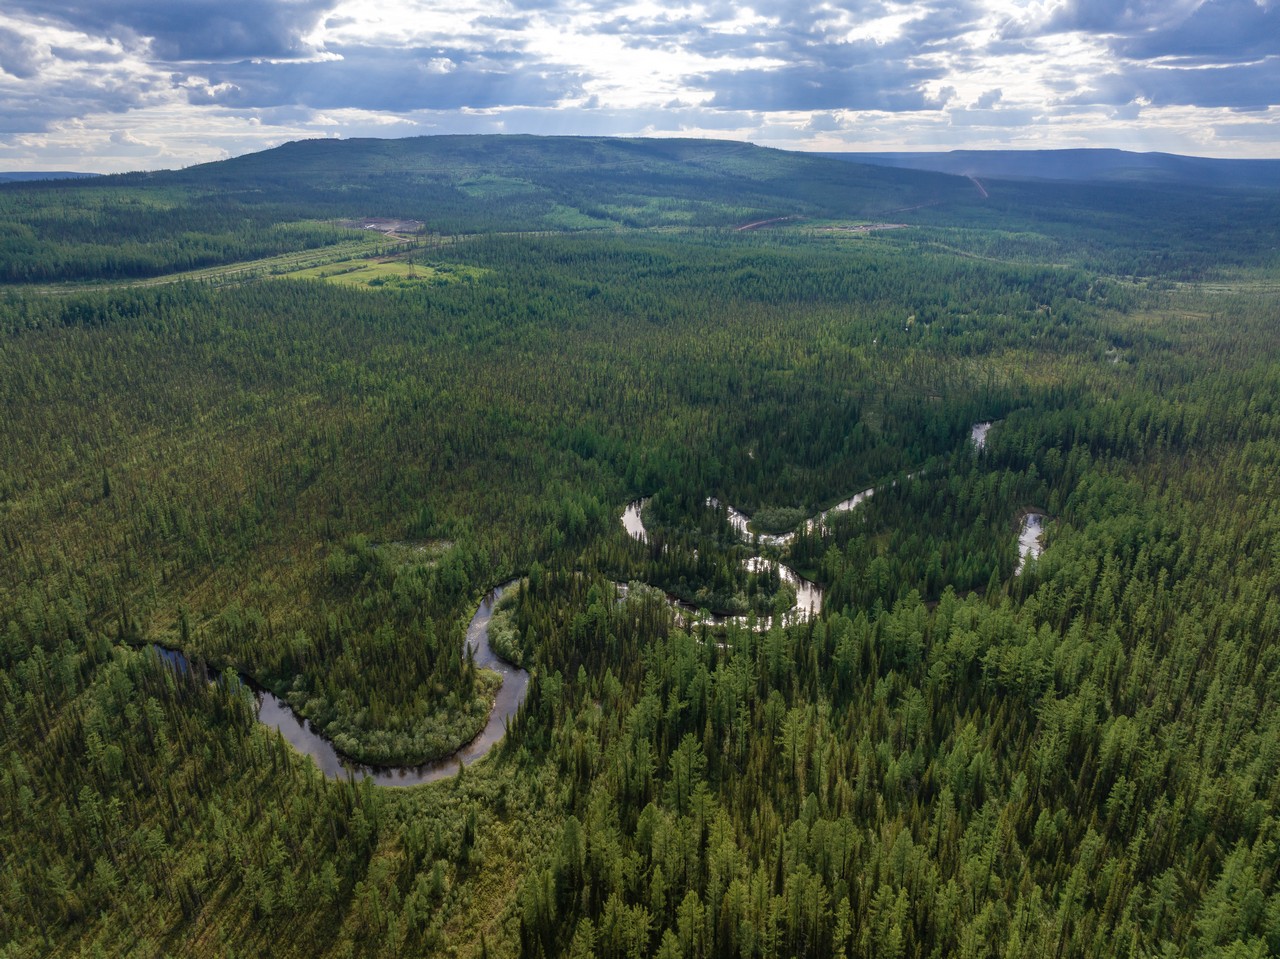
left=145, top=136, right=973, bottom=232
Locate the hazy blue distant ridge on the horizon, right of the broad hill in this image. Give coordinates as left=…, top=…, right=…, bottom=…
left=822, top=150, right=1280, bottom=188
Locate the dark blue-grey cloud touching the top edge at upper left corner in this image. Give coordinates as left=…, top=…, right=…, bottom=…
left=14, top=0, right=334, bottom=61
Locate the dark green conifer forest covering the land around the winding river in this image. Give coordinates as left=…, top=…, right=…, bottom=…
left=0, top=137, right=1280, bottom=959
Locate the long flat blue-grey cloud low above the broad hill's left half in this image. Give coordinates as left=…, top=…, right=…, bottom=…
left=180, top=47, right=582, bottom=113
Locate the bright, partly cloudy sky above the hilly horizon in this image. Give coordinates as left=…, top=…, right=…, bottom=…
left=0, top=0, right=1280, bottom=173
